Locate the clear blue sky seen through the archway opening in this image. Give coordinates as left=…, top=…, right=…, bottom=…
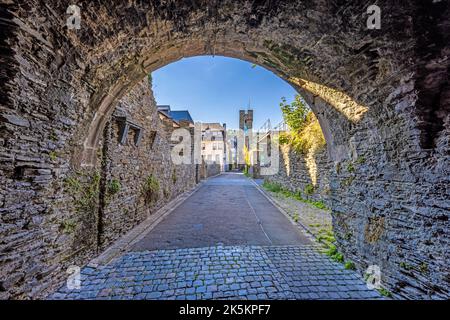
left=152, top=56, right=296, bottom=129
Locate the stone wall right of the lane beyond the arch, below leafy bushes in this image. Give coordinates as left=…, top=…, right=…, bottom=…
left=262, top=145, right=333, bottom=207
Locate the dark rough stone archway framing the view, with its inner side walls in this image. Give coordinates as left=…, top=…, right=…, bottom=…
left=0, top=0, right=450, bottom=297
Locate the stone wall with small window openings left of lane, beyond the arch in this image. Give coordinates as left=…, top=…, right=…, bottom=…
left=96, top=79, right=195, bottom=248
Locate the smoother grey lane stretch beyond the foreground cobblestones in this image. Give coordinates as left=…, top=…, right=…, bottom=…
left=133, top=173, right=311, bottom=251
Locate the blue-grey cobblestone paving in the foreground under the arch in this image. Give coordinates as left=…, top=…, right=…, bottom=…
left=50, top=245, right=381, bottom=300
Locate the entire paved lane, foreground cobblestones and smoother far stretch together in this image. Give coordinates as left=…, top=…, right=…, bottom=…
left=50, top=174, right=381, bottom=300
